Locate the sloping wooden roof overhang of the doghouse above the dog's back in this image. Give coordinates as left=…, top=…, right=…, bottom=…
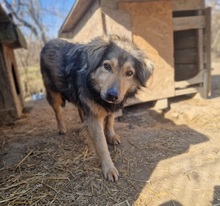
left=58, top=0, right=95, bottom=37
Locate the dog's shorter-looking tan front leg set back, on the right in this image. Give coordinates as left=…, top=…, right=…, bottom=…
left=105, top=113, right=121, bottom=144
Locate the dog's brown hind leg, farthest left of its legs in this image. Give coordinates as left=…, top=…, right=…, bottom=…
left=47, top=91, right=66, bottom=134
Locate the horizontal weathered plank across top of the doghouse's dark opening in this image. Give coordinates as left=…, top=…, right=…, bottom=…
left=173, top=16, right=205, bottom=31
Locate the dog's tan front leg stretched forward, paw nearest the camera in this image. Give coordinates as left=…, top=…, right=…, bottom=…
left=86, top=115, right=119, bottom=181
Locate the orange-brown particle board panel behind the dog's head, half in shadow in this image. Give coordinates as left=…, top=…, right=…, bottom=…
left=119, top=0, right=174, bottom=103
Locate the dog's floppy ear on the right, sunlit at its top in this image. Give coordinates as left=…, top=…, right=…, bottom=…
left=136, top=57, right=154, bottom=87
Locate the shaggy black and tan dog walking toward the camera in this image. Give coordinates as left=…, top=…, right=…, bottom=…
left=40, top=35, right=153, bottom=181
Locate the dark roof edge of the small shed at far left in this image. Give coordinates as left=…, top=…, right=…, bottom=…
left=0, top=4, right=27, bottom=49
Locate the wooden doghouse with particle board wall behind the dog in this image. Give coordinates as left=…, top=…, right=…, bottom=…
left=59, top=0, right=211, bottom=107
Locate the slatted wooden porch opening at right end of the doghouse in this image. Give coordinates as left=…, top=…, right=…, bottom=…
left=174, top=5, right=211, bottom=98
